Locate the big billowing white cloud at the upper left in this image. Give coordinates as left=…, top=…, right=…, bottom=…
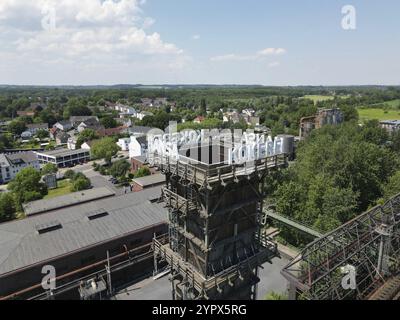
left=0, top=0, right=189, bottom=78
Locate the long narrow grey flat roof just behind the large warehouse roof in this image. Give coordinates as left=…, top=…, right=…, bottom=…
left=23, top=187, right=115, bottom=216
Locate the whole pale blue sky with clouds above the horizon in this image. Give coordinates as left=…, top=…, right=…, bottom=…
left=0, top=0, right=400, bottom=86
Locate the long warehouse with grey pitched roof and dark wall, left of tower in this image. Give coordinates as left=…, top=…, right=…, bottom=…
left=0, top=187, right=167, bottom=298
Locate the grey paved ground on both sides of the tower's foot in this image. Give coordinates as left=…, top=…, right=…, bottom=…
left=115, top=258, right=288, bottom=300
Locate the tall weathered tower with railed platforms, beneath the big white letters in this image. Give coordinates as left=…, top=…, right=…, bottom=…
left=154, top=146, right=287, bottom=300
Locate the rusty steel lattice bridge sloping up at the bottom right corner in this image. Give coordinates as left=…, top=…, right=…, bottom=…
left=282, top=194, right=400, bottom=300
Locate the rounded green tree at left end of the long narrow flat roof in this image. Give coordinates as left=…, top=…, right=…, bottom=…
left=7, top=167, right=47, bottom=209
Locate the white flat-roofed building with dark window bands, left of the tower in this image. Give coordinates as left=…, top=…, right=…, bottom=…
left=36, top=149, right=90, bottom=168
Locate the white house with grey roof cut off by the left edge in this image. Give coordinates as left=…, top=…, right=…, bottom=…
left=0, top=151, right=40, bottom=184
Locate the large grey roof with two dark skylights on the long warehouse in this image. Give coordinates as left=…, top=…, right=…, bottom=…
left=0, top=187, right=168, bottom=277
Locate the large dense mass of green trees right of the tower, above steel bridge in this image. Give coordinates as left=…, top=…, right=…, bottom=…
left=268, top=121, right=400, bottom=245
